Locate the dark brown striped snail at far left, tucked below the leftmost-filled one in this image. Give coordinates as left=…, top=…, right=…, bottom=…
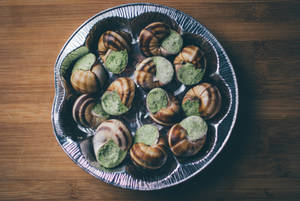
left=72, top=94, right=109, bottom=128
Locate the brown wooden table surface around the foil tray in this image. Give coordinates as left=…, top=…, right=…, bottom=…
left=0, top=0, right=300, bottom=201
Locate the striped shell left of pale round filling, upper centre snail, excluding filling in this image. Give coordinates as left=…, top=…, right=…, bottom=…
left=134, top=57, right=164, bottom=89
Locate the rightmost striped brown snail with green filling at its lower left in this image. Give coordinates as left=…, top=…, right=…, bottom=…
left=182, top=83, right=222, bottom=119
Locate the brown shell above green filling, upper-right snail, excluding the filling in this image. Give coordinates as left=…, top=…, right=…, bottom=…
left=173, top=45, right=207, bottom=71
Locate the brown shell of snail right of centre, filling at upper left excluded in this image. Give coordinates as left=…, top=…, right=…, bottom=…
left=147, top=88, right=180, bottom=126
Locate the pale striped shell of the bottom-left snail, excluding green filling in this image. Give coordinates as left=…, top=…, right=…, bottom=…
left=95, top=119, right=132, bottom=151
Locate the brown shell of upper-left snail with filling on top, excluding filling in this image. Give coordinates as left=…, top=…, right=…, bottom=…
left=71, top=63, right=107, bottom=94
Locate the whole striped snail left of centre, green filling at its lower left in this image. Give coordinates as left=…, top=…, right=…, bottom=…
left=101, top=77, right=135, bottom=116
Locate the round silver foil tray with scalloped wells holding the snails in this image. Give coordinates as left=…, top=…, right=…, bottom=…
left=51, top=3, right=238, bottom=191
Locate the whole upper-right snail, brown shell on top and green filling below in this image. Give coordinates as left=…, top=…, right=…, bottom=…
left=173, top=45, right=206, bottom=85
